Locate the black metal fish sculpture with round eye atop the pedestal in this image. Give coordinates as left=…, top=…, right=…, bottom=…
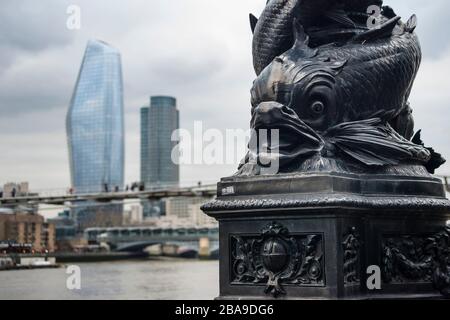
left=238, top=0, right=445, bottom=175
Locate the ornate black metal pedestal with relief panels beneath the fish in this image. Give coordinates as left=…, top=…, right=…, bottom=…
left=203, top=173, right=450, bottom=299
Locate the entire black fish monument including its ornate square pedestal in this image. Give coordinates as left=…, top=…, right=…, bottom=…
left=202, top=0, right=450, bottom=299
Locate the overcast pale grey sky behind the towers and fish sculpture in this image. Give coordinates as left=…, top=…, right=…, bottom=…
left=0, top=0, right=450, bottom=195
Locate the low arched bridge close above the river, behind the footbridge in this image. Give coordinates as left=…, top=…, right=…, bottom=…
left=84, top=227, right=219, bottom=253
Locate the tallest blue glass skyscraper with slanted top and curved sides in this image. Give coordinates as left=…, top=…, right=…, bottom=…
left=66, top=40, right=125, bottom=229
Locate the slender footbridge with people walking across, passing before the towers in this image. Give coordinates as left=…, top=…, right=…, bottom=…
left=0, top=185, right=217, bottom=207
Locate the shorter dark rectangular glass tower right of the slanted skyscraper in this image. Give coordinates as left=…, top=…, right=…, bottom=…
left=141, top=96, right=180, bottom=217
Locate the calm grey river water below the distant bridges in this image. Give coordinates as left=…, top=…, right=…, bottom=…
left=0, top=259, right=219, bottom=300
